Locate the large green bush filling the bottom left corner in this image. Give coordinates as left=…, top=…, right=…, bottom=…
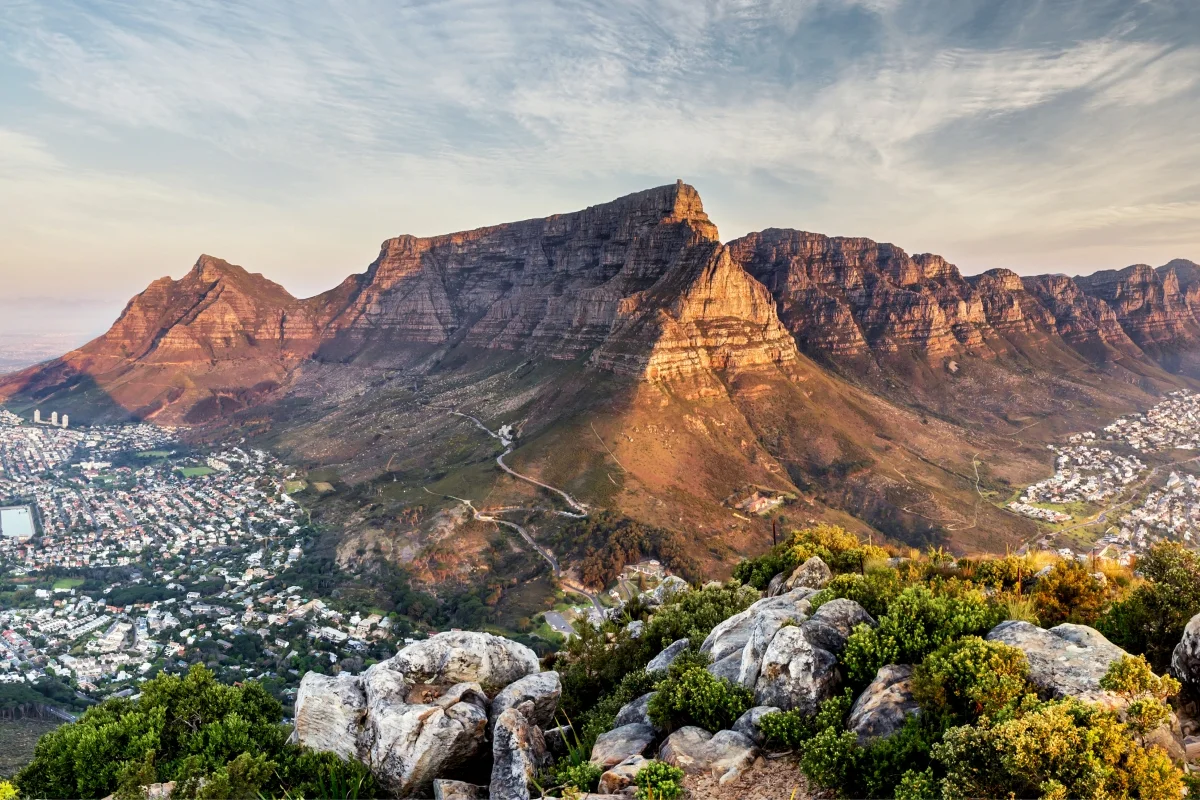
left=16, top=664, right=378, bottom=798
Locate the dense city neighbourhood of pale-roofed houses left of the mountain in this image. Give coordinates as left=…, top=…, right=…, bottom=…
left=0, top=411, right=405, bottom=705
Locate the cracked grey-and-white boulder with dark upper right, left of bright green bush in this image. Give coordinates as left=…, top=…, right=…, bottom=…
left=755, top=599, right=875, bottom=714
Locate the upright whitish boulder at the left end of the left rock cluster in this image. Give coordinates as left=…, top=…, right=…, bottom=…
left=295, top=672, right=367, bottom=759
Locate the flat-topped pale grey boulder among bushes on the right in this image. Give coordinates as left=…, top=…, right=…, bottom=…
left=986, top=620, right=1128, bottom=706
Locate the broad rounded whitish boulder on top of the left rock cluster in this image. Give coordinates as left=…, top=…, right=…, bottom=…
left=371, top=631, right=541, bottom=694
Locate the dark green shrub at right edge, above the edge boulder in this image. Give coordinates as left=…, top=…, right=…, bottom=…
left=1096, top=542, right=1200, bottom=672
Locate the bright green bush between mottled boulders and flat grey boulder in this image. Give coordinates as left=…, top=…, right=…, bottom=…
left=841, top=587, right=1003, bottom=686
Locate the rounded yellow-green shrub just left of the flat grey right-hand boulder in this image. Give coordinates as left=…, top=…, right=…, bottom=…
left=913, top=636, right=1032, bottom=727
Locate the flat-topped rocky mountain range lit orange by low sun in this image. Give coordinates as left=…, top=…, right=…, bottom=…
left=0, top=182, right=1200, bottom=568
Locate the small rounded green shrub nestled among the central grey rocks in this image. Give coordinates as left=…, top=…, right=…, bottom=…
left=649, top=664, right=754, bottom=730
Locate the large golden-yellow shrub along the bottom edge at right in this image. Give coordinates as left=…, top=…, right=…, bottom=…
left=934, top=699, right=1183, bottom=800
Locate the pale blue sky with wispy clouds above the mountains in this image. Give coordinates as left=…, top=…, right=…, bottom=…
left=0, top=0, right=1200, bottom=338
